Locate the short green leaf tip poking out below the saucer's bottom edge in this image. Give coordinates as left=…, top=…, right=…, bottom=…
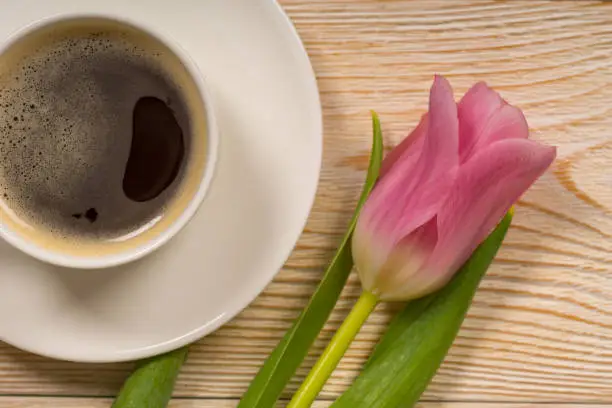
left=112, top=347, right=187, bottom=408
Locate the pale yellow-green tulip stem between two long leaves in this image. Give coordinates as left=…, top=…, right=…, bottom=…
left=287, top=291, right=378, bottom=408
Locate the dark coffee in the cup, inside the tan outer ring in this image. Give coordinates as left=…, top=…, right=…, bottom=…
left=0, top=20, right=190, bottom=240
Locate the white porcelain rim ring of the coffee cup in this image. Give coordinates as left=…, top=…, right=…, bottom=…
left=0, top=12, right=219, bottom=269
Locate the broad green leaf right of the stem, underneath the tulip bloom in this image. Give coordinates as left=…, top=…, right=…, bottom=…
left=332, top=213, right=512, bottom=408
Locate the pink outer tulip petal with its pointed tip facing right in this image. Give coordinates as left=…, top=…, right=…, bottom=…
left=427, top=139, right=556, bottom=275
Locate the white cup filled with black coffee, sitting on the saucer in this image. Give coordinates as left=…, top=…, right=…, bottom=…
left=0, top=15, right=219, bottom=269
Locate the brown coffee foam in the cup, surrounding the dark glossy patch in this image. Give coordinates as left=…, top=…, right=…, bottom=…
left=0, top=19, right=206, bottom=254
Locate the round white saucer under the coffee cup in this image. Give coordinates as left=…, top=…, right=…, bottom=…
left=0, top=0, right=322, bottom=362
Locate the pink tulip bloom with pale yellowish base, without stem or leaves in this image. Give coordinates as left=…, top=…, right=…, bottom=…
left=353, top=76, right=556, bottom=300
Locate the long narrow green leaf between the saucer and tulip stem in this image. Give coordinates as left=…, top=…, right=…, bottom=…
left=238, top=112, right=383, bottom=408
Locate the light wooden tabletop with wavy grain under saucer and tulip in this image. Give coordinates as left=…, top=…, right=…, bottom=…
left=0, top=0, right=612, bottom=408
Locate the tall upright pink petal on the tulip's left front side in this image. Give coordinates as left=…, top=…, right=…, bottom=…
left=357, top=76, right=459, bottom=248
